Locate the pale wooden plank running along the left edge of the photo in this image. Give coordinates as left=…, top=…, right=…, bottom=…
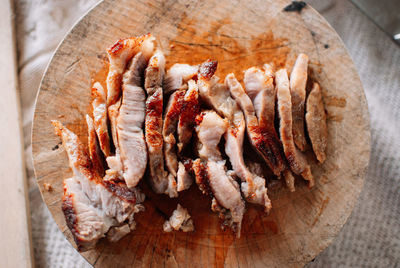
left=0, top=0, right=32, bottom=267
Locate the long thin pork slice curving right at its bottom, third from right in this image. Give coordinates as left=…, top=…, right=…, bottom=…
left=276, top=69, right=314, bottom=187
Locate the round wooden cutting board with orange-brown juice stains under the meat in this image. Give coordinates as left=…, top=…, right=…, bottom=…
left=32, top=0, right=370, bottom=267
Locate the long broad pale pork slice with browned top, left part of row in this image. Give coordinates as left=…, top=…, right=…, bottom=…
left=117, top=52, right=147, bottom=188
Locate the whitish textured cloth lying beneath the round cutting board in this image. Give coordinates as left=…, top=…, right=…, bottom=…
left=15, top=0, right=400, bottom=267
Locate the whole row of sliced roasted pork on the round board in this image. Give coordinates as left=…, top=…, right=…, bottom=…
left=53, top=34, right=327, bottom=251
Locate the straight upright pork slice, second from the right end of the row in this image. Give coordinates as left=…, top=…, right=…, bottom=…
left=290, top=54, right=308, bottom=151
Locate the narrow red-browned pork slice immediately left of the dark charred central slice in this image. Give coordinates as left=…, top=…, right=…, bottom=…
left=162, top=90, right=185, bottom=177
